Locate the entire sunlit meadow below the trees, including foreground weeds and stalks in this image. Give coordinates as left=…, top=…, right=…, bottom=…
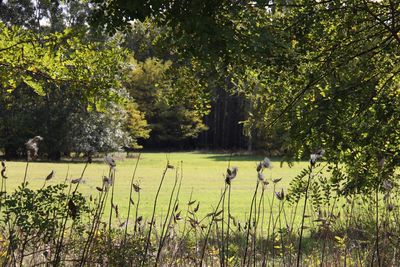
left=0, top=152, right=400, bottom=266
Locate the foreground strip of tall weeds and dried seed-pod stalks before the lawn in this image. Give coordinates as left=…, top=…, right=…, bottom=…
left=0, top=141, right=400, bottom=266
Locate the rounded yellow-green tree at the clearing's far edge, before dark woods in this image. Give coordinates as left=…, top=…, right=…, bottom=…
left=125, top=55, right=208, bottom=144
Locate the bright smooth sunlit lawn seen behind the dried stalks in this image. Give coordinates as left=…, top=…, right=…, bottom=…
left=3, top=152, right=307, bottom=223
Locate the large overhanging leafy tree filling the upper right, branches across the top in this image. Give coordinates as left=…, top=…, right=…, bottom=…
left=87, top=0, right=400, bottom=192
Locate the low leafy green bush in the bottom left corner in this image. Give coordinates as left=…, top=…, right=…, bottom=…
left=1, top=184, right=91, bottom=263
